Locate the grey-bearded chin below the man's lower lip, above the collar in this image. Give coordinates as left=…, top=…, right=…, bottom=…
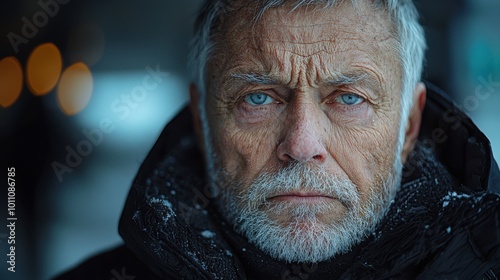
left=237, top=206, right=367, bottom=263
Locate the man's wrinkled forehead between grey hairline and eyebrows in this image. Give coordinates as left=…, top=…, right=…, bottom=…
left=209, top=1, right=400, bottom=89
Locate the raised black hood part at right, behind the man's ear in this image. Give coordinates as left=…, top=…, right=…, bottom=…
left=419, top=83, right=500, bottom=193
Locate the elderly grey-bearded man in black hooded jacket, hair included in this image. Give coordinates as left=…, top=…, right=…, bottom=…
left=55, top=0, right=500, bottom=279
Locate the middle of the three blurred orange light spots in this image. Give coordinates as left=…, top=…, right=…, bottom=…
left=26, top=43, right=62, bottom=95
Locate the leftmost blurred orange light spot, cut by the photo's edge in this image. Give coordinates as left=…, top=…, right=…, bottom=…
left=0, top=56, right=23, bottom=108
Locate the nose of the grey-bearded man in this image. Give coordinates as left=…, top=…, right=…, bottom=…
left=277, top=101, right=327, bottom=164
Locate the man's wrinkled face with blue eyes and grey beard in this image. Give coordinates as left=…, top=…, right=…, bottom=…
left=199, top=3, right=402, bottom=261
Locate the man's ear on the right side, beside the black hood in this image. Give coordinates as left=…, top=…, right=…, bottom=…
left=401, top=83, right=427, bottom=163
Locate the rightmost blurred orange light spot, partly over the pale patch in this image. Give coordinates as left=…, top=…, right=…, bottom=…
left=57, top=62, right=93, bottom=115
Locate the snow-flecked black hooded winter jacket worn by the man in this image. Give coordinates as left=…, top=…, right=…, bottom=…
left=56, top=85, right=500, bottom=280
